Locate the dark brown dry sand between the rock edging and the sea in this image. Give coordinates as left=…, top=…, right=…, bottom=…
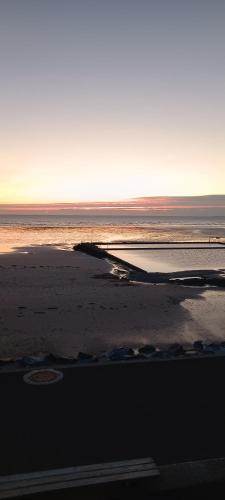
left=0, top=247, right=221, bottom=358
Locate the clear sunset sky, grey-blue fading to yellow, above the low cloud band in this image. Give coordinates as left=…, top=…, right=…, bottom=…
left=0, top=0, right=225, bottom=204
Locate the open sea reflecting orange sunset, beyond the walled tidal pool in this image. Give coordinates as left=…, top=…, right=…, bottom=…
left=0, top=214, right=225, bottom=252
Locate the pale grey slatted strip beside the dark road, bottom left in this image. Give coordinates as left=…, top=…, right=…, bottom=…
left=0, top=458, right=159, bottom=499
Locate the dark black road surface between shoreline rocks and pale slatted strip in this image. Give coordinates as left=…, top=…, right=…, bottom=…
left=0, top=357, right=225, bottom=475
